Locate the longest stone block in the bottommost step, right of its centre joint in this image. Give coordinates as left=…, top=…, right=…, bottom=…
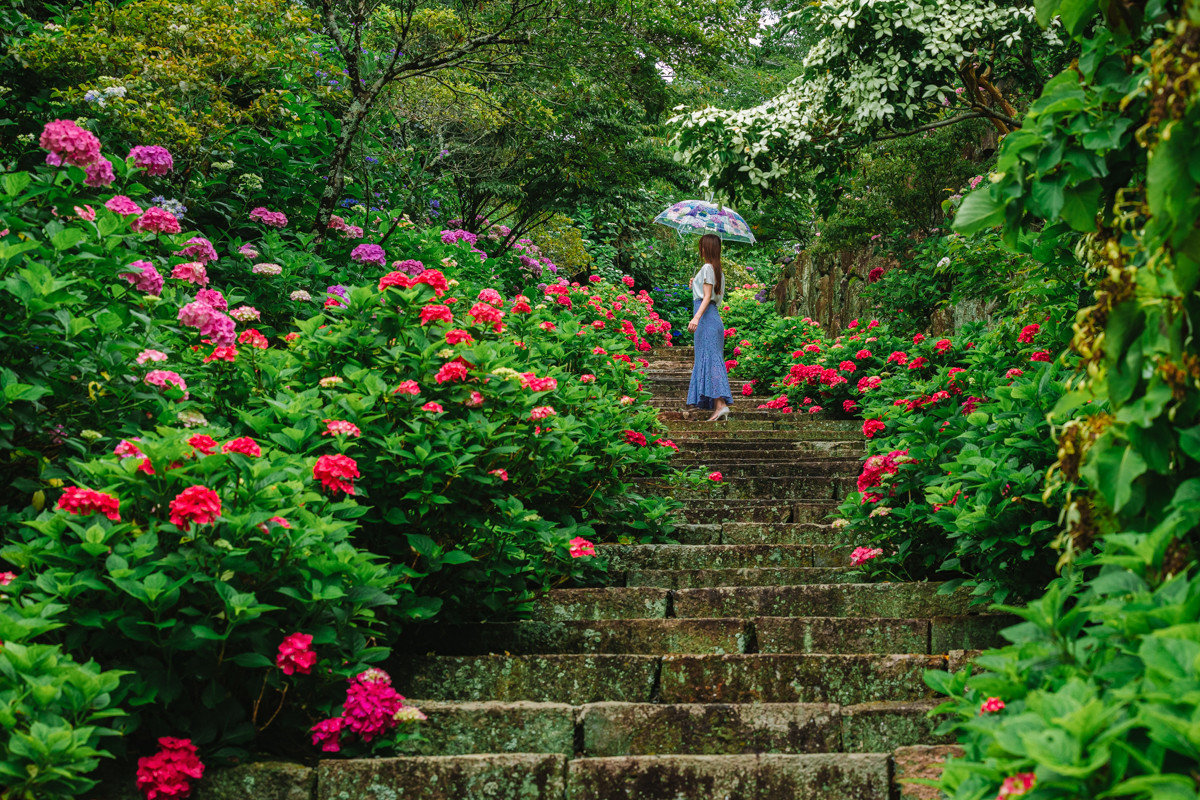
left=564, top=753, right=890, bottom=800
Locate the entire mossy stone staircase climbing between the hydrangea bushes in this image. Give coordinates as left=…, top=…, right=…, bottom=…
left=355, top=348, right=993, bottom=800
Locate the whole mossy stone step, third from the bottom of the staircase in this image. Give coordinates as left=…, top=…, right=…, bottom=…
left=403, top=654, right=949, bottom=705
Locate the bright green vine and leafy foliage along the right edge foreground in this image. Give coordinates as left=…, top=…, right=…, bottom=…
left=930, top=0, right=1200, bottom=800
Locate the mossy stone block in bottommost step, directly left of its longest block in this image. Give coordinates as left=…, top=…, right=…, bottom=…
left=317, top=753, right=566, bottom=800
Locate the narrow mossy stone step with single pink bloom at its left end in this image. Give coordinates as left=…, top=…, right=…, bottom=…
left=596, top=543, right=850, bottom=571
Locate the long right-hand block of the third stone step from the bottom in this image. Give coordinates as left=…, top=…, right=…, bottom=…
left=655, top=654, right=948, bottom=705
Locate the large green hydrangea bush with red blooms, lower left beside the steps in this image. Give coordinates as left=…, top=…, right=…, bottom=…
left=0, top=428, right=397, bottom=750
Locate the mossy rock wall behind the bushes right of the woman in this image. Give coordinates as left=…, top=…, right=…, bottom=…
left=773, top=247, right=998, bottom=333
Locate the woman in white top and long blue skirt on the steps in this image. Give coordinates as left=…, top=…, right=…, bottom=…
left=688, top=234, right=733, bottom=422
